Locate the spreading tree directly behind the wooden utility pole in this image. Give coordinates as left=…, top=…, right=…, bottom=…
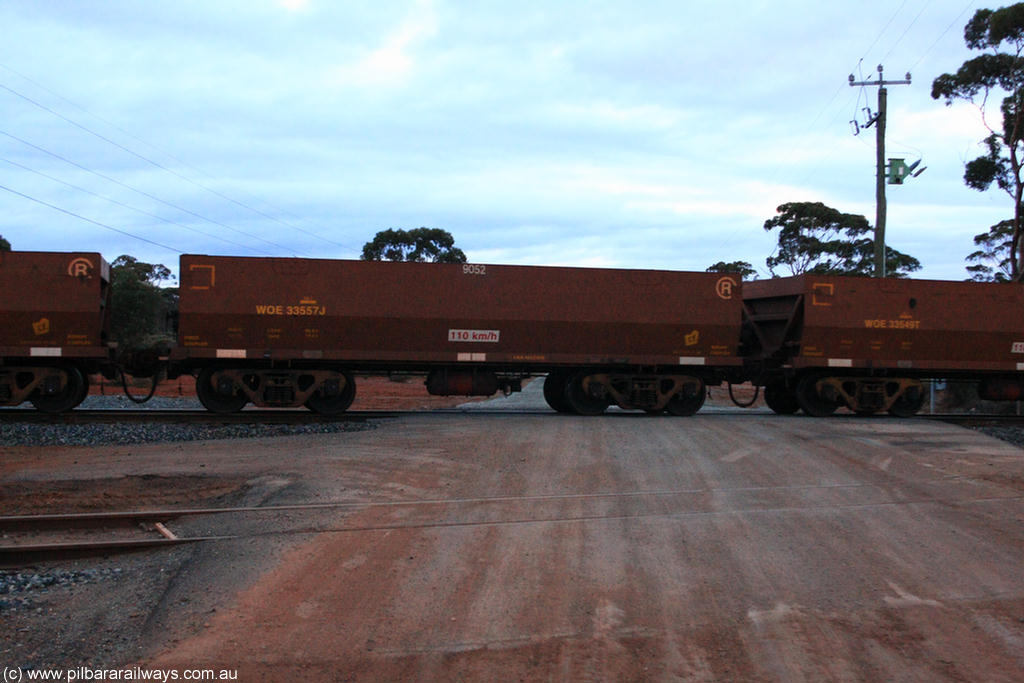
left=765, top=202, right=921, bottom=278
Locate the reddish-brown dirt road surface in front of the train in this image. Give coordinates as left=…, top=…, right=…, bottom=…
left=0, top=387, right=1024, bottom=683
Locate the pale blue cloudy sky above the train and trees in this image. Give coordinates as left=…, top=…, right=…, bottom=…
left=0, top=0, right=1012, bottom=280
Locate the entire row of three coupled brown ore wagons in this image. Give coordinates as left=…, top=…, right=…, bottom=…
left=8, top=246, right=1024, bottom=416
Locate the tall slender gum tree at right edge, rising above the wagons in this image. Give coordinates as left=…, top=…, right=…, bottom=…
left=932, top=3, right=1024, bottom=281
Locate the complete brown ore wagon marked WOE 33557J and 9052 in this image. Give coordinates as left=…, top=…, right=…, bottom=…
left=172, top=255, right=741, bottom=415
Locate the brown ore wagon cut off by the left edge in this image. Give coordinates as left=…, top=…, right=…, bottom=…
left=0, top=251, right=112, bottom=413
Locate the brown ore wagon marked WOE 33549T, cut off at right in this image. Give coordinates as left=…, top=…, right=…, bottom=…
left=743, top=274, right=1024, bottom=416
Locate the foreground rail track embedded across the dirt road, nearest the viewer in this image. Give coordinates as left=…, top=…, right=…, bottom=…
left=8, top=479, right=1021, bottom=568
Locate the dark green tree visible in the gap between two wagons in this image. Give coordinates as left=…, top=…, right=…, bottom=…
left=111, top=254, right=177, bottom=351
